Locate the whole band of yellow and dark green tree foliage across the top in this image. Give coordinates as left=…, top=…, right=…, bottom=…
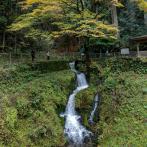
left=0, top=0, right=147, bottom=53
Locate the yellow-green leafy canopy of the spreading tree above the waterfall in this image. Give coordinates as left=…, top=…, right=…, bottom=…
left=10, top=0, right=116, bottom=51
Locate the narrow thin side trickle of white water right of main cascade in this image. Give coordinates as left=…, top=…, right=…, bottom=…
left=89, top=94, right=99, bottom=123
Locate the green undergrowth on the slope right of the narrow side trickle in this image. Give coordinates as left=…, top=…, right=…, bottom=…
left=90, top=58, right=147, bottom=147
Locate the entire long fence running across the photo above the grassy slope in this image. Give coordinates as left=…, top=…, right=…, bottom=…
left=0, top=52, right=144, bottom=67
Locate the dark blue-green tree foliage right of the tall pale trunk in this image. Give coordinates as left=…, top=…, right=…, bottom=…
left=118, top=0, right=147, bottom=46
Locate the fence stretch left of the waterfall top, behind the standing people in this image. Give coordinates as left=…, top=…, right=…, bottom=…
left=0, top=52, right=81, bottom=67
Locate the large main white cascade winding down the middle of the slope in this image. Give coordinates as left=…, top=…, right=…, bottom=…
left=62, top=62, right=92, bottom=146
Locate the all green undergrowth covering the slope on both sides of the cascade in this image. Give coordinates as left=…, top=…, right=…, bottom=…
left=0, top=58, right=147, bottom=147
